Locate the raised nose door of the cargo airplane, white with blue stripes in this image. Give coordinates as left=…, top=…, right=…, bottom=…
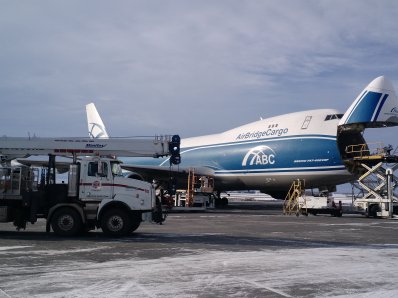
left=339, top=76, right=398, bottom=130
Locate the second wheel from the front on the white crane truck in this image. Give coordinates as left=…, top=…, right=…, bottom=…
left=51, top=208, right=83, bottom=236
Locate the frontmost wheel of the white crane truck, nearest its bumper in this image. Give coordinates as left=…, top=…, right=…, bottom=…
left=101, top=208, right=131, bottom=237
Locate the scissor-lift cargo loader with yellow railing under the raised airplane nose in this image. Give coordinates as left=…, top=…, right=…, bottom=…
left=346, top=144, right=398, bottom=217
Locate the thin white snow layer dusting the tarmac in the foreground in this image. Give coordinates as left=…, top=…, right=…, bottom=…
left=0, top=246, right=398, bottom=297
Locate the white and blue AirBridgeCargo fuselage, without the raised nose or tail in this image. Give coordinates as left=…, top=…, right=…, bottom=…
left=128, top=109, right=353, bottom=197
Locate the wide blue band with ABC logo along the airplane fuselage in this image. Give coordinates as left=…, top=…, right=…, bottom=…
left=128, top=135, right=345, bottom=174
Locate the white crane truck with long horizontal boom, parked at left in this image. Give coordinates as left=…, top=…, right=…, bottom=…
left=0, top=137, right=180, bottom=236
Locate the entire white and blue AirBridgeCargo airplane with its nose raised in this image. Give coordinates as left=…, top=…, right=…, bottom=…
left=87, top=76, right=398, bottom=199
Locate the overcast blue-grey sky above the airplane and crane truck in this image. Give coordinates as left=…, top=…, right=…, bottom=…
left=0, top=0, right=398, bottom=145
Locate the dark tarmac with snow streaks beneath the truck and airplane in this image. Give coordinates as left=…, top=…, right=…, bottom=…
left=0, top=203, right=398, bottom=297
